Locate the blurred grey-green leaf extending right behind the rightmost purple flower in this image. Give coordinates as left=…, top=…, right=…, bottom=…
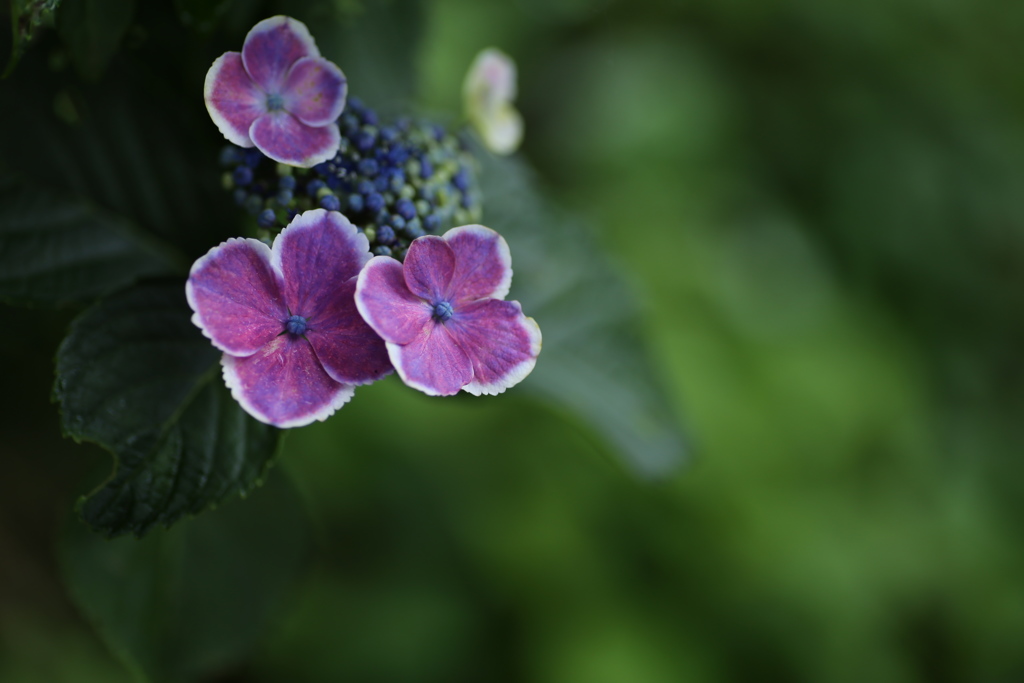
left=479, top=152, right=685, bottom=476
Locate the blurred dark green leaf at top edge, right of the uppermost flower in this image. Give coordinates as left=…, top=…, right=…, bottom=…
left=281, top=0, right=425, bottom=117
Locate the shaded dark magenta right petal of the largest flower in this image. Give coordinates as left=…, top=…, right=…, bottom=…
left=306, top=278, right=392, bottom=384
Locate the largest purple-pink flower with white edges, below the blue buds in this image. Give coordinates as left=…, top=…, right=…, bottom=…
left=185, top=209, right=391, bottom=428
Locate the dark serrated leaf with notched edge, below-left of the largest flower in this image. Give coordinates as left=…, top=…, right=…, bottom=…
left=54, top=281, right=282, bottom=536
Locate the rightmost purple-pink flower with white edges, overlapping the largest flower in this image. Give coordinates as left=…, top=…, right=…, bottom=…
left=355, top=225, right=541, bottom=396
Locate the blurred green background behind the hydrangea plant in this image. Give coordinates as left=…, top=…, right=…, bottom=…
left=0, top=0, right=1024, bottom=683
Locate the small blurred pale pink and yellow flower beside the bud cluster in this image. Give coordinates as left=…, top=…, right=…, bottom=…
left=462, top=47, right=522, bottom=155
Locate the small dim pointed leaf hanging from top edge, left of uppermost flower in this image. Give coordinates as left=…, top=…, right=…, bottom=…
left=57, top=0, right=135, bottom=81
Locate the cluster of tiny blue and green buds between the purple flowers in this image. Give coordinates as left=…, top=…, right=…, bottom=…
left=220, top=97, right=481, bottom=260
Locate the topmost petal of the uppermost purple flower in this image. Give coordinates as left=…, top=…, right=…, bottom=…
left=242, top=15, right=319, bottom=93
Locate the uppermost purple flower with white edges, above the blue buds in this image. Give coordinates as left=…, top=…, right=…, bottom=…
left=204, top=16, right=348, bottom=168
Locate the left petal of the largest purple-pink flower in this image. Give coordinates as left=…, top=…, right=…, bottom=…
left=185, top=239, right=288, bottom=355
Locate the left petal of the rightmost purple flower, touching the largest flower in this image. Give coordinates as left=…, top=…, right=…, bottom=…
left=355, top=256, right=431, bottom=344
